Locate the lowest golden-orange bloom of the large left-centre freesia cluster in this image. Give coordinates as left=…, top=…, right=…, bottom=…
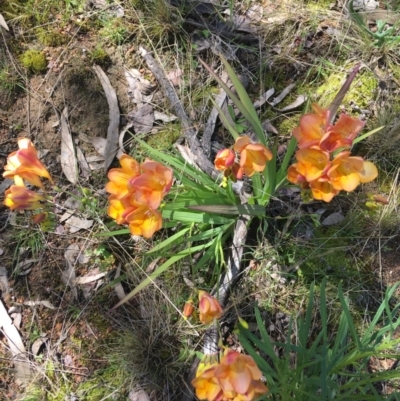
left=123, top=205, right=162, bottom=238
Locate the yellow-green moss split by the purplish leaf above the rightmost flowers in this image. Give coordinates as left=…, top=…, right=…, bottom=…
left=315, top=71, right=377, bottom=108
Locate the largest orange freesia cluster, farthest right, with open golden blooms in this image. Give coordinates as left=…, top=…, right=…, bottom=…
left=287, top=104, right=378, bottom=202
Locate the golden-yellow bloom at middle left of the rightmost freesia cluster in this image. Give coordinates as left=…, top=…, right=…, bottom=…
left=296, top=149, right=330, bottom=181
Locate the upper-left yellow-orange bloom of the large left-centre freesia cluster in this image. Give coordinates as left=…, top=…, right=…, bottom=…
left=106, top=155, right=140, bottom=199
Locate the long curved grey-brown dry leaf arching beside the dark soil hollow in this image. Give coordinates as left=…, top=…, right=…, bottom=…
left=93, top=65, right=120, bottom=169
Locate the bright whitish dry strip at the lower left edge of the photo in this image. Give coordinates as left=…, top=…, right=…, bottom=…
left=0, top=301, right=31, bottom=385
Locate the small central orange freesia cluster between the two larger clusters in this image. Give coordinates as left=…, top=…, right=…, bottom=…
left=214, top=135, right=272, bottom=181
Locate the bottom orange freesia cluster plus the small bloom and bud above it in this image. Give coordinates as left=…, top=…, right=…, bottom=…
left=183, top=291, right=268, bottom=401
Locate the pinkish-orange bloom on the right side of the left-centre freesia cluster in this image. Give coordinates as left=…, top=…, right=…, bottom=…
left=128, top=160, right=173, bottom=209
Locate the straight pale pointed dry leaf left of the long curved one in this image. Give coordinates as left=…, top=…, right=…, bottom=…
left=60, top=107, right=78, bottom=184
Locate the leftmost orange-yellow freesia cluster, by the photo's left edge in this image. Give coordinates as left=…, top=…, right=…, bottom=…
left=3, top=138, right=53, bottom=216
